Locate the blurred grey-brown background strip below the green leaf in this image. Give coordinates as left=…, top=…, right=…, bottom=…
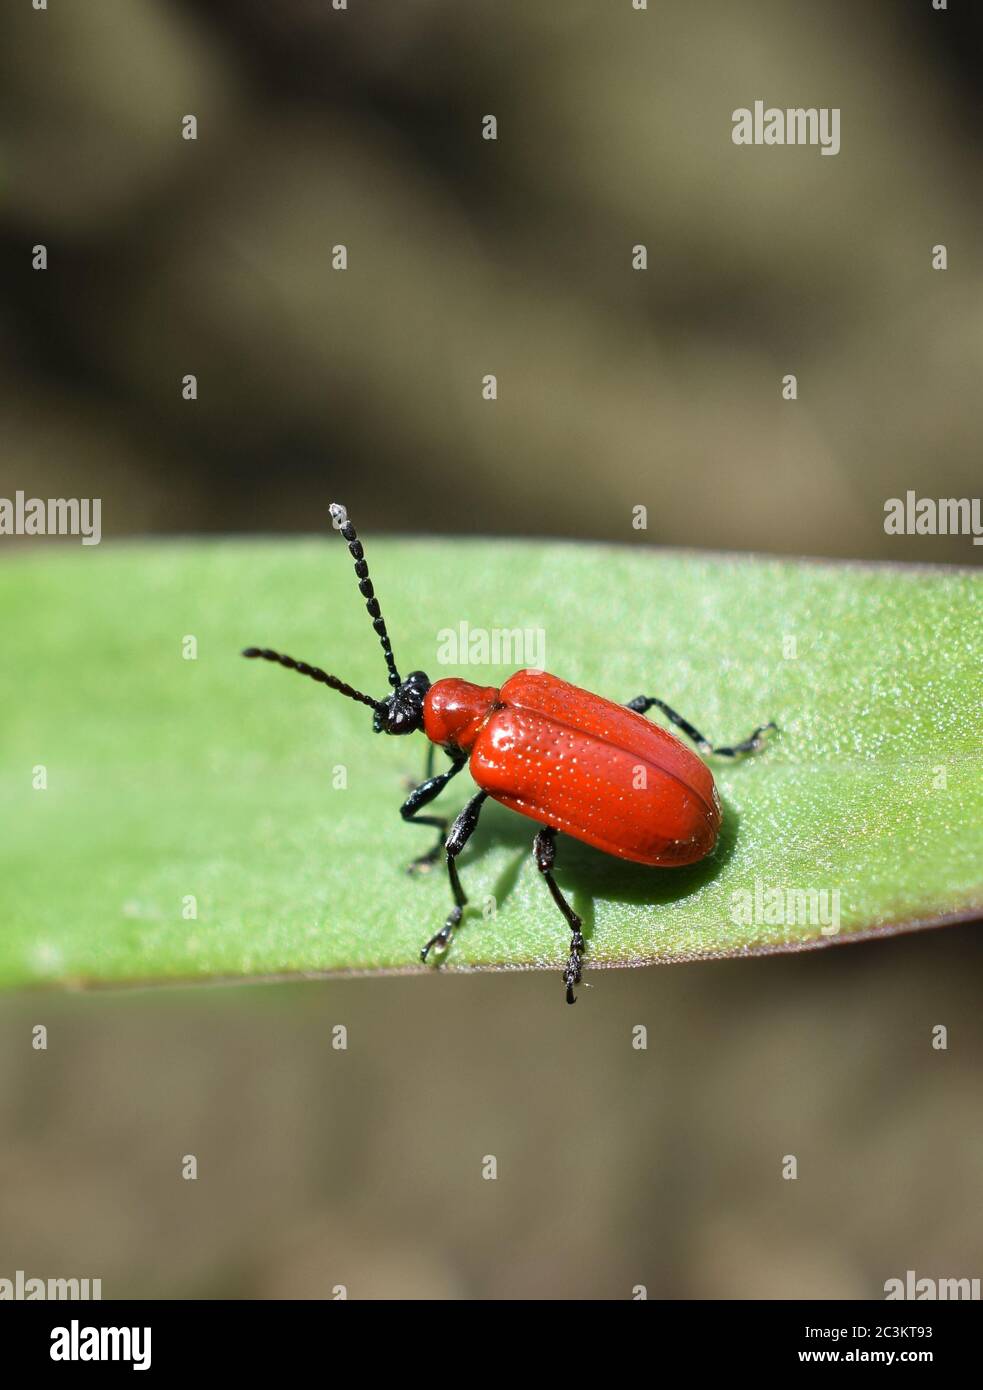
left=0, top=934, right=983, bottom=1298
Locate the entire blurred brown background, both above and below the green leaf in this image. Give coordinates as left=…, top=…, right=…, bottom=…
left=0, top=0, right=983, bottom=1298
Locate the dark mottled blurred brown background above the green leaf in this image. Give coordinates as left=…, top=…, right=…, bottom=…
left=0, top=0, right=983, bottom=563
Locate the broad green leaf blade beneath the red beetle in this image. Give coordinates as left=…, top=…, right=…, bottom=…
left=0, top=532, right=983, bottom=988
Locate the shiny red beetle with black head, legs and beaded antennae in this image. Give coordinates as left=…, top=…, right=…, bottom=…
left=242, top=503, right=776, bottom=1004
